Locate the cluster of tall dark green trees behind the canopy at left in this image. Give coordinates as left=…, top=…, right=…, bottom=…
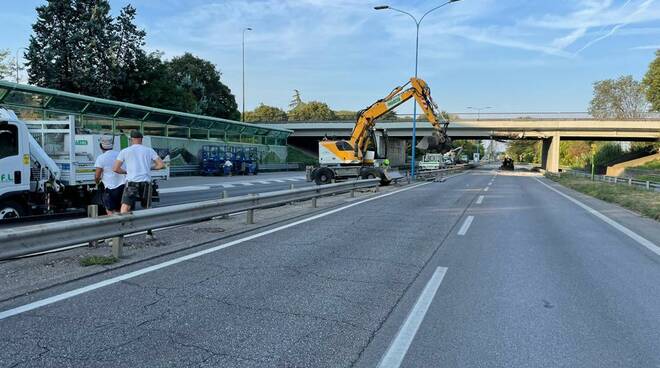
left=25, top=0, right=240, bottom=119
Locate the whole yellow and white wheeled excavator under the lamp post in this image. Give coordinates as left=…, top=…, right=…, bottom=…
left=310, top=78, right=450, bottom=185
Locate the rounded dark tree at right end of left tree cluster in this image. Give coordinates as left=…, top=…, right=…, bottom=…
left=168, top=53, right=241, bottom=120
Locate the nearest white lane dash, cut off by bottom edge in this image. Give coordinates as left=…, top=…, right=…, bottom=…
left=378, top=267, right=447, bottom=368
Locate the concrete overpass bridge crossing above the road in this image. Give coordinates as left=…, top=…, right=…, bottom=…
left=266, top=118, right=660, bottom=172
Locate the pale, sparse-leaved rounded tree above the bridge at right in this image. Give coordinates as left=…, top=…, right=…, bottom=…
left=589, top=75, right=648, bottom=119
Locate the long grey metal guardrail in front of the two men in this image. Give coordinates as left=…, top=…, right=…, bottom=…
left=0, top=179, right=380, bottom=260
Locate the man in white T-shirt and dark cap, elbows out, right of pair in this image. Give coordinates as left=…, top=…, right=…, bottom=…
left=112, top=130, right=165, bottom=213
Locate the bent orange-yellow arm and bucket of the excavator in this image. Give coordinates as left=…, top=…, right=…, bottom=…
left=348, top=78, right=449, bottom=158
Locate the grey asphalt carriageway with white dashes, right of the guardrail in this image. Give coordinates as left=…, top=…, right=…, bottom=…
left=0, top=171, right=660, bottom=367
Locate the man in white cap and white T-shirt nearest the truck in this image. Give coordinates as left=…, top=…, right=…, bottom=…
left=94, top=136, right=126, bottom=215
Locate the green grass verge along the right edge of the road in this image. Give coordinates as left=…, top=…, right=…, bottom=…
left=547, top=175, right=660, bottom=221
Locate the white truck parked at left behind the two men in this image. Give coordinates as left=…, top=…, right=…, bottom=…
left=0, top=108, right=169, bottom=221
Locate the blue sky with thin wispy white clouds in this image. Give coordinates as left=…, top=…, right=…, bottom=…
left=0, top=0, right=660, bottom=113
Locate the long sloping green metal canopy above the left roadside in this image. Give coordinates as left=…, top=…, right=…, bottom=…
left=0, top=81, right=293, bottom=139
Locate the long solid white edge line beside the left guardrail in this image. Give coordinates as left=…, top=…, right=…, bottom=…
left=0, top=182, right=432, bottom=320
